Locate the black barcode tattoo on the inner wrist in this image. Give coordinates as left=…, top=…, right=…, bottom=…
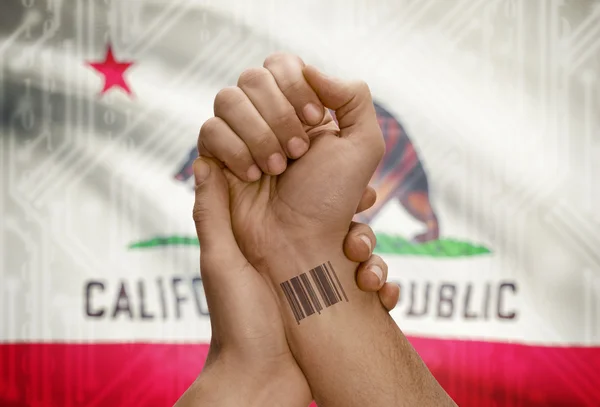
left=280, top=262, right=348, bottom=324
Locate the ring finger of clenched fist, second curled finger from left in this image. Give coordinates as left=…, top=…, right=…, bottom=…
left=214, top=86, right=287, bottom=175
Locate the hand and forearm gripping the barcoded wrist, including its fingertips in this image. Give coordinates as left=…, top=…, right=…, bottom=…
left=176, top=59, right=399, bottom=407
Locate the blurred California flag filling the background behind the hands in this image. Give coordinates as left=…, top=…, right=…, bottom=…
left=0, top=0, right=600, bottom=407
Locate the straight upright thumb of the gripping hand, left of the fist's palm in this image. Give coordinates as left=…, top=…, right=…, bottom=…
left=193, top=157, right=247, bottom=273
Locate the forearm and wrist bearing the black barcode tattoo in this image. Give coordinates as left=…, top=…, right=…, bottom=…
left=261, top=245, right=454, bottom=407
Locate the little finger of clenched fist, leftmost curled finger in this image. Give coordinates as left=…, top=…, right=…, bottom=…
left=198, top=117, right=262, bottom=182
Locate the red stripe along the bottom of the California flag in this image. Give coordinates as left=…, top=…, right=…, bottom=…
left=0, top=337, right=600, bottom=407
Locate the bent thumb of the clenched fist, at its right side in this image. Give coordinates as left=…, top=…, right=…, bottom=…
left=303, top=65, right=385, bottom=168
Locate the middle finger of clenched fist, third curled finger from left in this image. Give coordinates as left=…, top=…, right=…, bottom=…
left=238, top=68, right=309, bottom=159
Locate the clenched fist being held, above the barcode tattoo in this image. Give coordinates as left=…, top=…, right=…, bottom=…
left=198, top=54, right=385, bottom=283
